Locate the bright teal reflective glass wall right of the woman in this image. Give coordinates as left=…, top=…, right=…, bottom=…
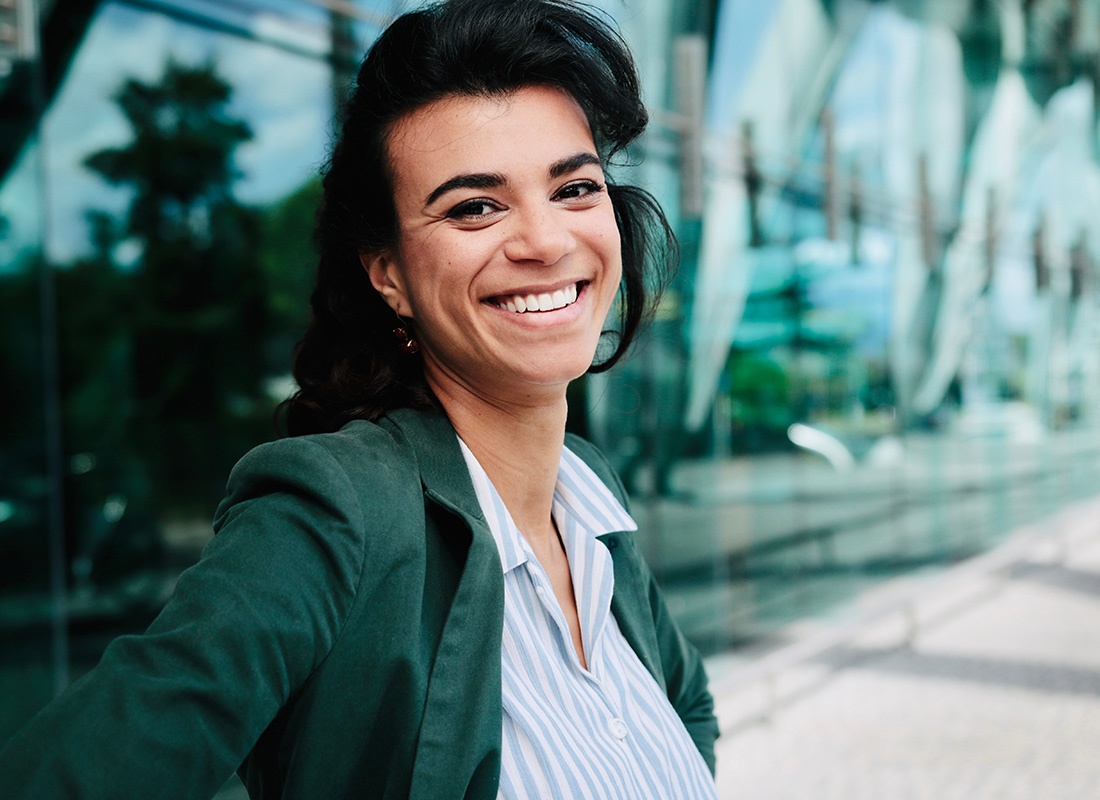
left=589, top=0, right=1100, bottom=654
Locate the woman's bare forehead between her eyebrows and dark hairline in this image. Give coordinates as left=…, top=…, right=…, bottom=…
left=386, top=86, right=596, bottom=200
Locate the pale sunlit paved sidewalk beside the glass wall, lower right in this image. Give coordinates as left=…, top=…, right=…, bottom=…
left=718, top=516, right=1100, bottom=800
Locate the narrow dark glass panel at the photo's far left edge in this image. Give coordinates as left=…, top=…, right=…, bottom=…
left=0, top=129, right=57, bottom=739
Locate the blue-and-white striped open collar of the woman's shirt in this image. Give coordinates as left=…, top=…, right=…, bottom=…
left=459, top=438, right=638, bottom=572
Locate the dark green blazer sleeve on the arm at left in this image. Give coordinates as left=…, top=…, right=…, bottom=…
left=0, top=439, right=364, bottom=800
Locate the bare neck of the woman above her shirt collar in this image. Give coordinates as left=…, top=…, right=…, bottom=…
left=429, top=380, right=568, bottom=551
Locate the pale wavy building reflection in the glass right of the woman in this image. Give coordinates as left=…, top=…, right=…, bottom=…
left=664, top=0, right=1100, bottom=437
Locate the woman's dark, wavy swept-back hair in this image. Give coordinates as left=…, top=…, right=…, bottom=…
left=281, top=0, right=675, bottom=436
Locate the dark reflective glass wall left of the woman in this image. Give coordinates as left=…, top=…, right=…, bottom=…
left=0, top=0, right=392, bottom=738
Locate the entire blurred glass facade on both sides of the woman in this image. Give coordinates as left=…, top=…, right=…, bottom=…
left=0, top=0, right=1100, bottom=783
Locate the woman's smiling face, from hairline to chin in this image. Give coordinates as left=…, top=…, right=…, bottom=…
left=363, top=87, right=622, bottom=407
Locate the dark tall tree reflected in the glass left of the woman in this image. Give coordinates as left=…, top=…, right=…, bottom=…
left=71, top=61, right=266, bottom=506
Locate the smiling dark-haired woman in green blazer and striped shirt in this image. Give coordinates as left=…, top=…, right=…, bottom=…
left=0, top=0, right=717, bottom=800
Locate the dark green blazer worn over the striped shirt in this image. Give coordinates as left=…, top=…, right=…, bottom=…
left=0, top=409, right=717, bottom=800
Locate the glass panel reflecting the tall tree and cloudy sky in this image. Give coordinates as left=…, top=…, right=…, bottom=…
left=45, top=4, right=331, bottom=655
